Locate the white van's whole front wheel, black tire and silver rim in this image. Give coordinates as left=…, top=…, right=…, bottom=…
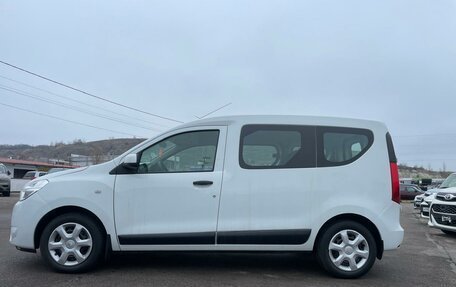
left=40, top=213, right=105, bottom=273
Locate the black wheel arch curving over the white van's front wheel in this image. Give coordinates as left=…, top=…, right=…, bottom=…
left=33, top=205, right=108, bottom=249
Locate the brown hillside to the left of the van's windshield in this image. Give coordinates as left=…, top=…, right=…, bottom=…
left=0, top=138, right=145, bottom=162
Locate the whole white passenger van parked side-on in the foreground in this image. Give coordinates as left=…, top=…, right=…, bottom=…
left=10, top=116, right=404, bottom=278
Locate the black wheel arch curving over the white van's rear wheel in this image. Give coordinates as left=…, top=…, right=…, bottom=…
left=313, top=213, right=384, bottom=259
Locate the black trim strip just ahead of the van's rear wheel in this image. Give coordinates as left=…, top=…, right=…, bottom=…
left=217, top=229, right=311, bottom=245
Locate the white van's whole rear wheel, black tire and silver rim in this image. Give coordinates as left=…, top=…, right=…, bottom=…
left=316, top=221, right=377, bottom=279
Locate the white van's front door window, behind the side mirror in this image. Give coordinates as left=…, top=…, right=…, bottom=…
left=138, top=130, right=219, bottom=176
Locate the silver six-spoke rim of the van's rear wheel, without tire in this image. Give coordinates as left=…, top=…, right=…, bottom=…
left=328, top=229, right=369, bottom=271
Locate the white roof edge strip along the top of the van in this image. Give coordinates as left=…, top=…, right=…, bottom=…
left=176, top=115, right=386, bottom=132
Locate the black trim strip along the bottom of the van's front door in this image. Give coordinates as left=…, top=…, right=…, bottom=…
left=119, top=232, right=215, bottom=245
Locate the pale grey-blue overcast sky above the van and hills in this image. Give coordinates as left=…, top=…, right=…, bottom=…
left=0, top=0, right=456, bottom=170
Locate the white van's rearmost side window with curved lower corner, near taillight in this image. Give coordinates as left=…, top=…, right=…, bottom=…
left=317, top=127, right=374, bottom=167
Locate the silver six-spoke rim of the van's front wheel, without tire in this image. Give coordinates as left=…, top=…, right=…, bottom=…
left=48, top=222, right=93, bottom=266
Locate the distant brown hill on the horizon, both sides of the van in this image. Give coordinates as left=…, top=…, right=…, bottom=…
left=0, top=138, right=451, bottom=179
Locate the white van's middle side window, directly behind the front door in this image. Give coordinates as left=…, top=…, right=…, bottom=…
left=239, top=125, right=315, bottom=169
